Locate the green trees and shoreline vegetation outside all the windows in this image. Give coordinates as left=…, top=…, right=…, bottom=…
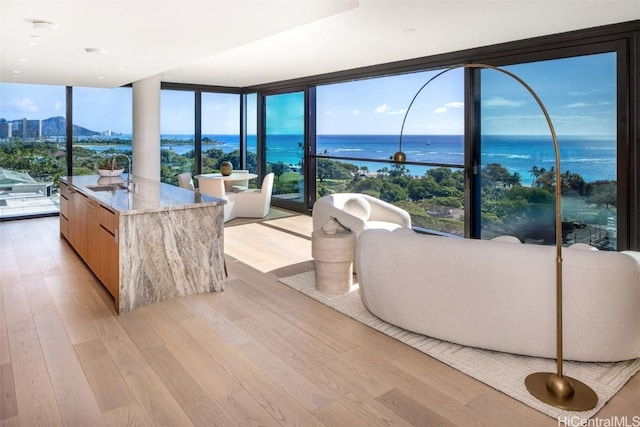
left=0, top=137, right=617, bottom=250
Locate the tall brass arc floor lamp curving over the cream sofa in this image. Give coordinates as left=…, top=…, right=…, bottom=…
left=393, top=63, right=598, bottom=411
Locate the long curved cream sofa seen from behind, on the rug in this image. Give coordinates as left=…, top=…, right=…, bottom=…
left=355, top=230, right=640, bottom=362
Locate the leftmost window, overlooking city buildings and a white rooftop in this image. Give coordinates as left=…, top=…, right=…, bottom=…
left=0, top=83, right=67, bottom=219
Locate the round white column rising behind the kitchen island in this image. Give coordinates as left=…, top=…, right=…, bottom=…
left=132, top=76, right=160, bottom=181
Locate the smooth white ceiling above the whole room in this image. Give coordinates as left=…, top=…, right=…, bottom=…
left=0, top=0, right=640, bottom=87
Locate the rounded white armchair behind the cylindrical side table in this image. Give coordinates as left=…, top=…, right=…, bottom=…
left=313, top=193, right=411, bottom=235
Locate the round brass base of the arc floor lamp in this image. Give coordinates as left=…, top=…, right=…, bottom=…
left=524, top=372, right=598, bottom=411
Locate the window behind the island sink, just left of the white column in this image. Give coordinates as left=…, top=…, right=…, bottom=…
left=72, top=87, right=133, bottom=175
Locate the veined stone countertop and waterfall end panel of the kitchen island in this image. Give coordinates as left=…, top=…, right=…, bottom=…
left=60, top=174, right=225, bottom=313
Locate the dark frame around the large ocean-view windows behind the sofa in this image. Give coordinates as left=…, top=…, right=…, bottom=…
left=243, top=20, right=640, bottom=249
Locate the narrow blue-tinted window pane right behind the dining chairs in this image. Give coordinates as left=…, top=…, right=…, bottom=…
left=264, top=91, right=305, bottom=204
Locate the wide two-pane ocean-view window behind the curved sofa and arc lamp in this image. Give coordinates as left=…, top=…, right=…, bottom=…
left=312, top=47, right=623, bottom=249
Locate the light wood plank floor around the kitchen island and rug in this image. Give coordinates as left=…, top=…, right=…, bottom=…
left=0, top=215, right=640, bottom=427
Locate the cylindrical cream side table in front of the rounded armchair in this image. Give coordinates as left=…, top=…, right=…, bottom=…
left=311, top=230, right=356, bottom=294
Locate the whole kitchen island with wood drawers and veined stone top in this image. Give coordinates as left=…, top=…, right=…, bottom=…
left=60, top=174, right=225, bottom=313
